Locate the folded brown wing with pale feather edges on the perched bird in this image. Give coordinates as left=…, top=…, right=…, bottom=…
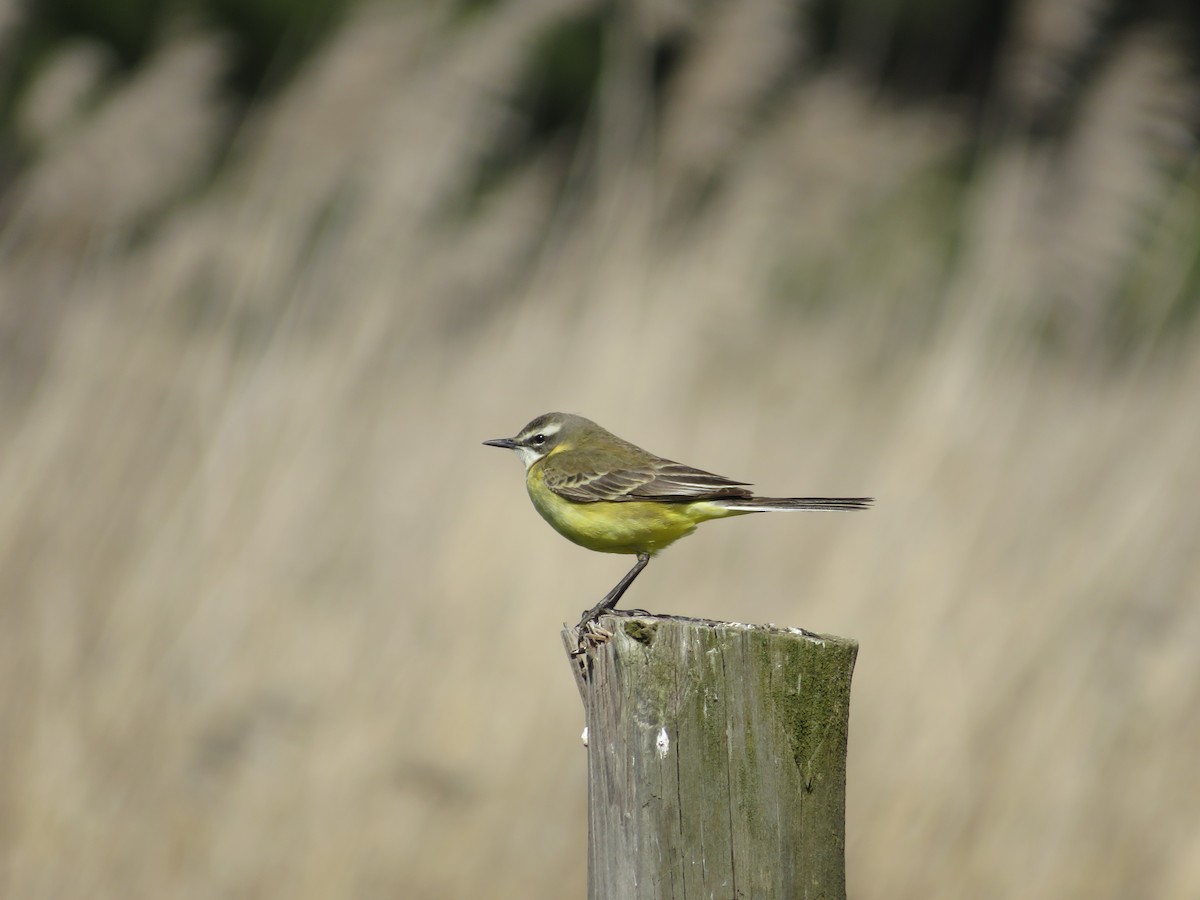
left=544, top=458, right=752, bottom=503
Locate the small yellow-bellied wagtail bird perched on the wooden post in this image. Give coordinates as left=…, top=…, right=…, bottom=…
left=484, top=413, right=872, bottom=629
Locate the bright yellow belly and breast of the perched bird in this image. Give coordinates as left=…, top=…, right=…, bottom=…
left=526, top=466, right=743, bottom=556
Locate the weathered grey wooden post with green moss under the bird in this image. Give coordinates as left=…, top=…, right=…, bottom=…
left=563, top=616, right=858, bottom=900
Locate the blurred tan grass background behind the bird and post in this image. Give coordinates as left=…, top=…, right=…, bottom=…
left=0, top=0, right=1200, bottom=900
